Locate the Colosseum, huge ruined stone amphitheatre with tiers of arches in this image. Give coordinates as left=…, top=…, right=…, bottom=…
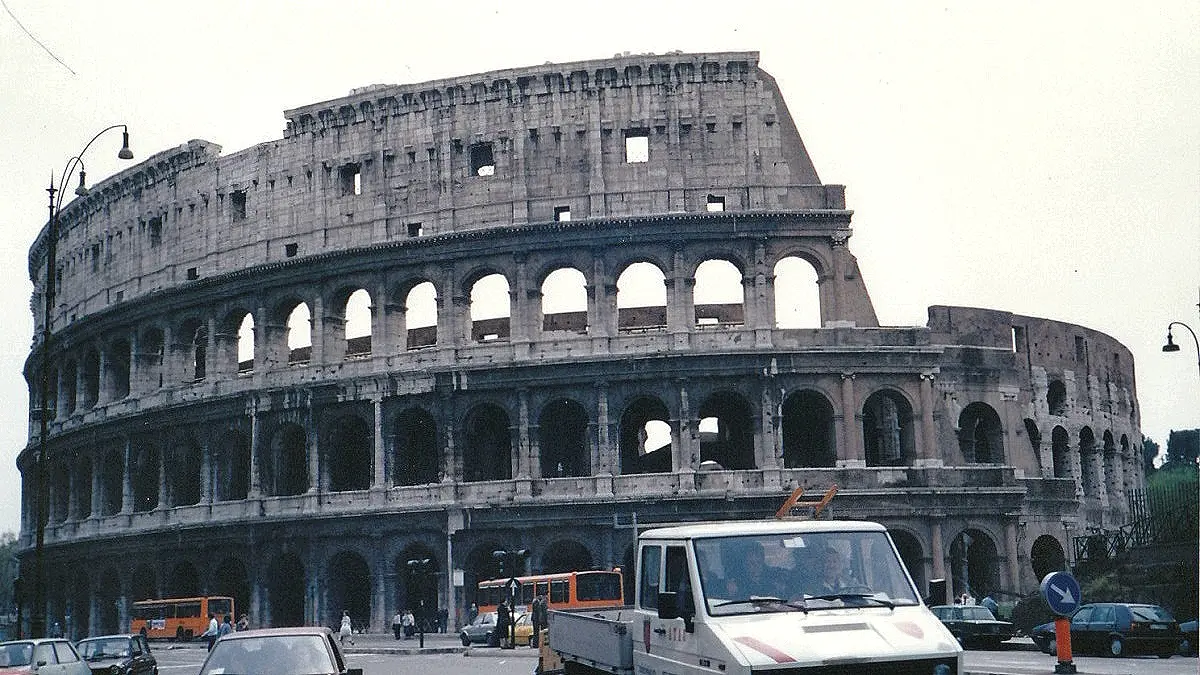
left=18, top=52, right=1144, bottom=637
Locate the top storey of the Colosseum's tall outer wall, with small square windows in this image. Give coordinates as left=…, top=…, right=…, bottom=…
left=30, top=52, right=849, bottom=333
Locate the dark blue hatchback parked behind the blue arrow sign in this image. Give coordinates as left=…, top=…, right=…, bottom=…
left=1030, top=603, right=1182, bottom=658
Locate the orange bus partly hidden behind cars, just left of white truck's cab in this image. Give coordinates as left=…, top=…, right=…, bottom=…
left=475, top=567, right=625, bottom=614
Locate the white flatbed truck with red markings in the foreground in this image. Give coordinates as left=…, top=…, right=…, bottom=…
left=549, top=520, right=962, bottom=675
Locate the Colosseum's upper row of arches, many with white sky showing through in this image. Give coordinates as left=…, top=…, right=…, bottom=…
left=39, top=255, right=822, bottom=417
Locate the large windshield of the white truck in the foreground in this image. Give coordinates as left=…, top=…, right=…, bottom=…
left=695, top=532, right=919, bottom=616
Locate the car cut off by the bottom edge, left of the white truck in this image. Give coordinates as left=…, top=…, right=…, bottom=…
left=200, top=627, right=362, bottom=675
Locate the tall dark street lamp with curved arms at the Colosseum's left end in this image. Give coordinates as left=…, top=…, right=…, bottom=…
left=30, top=124, right=133, bottom=637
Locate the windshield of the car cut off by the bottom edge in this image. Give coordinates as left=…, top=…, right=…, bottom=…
left=200, top=635, right=337, bottom=675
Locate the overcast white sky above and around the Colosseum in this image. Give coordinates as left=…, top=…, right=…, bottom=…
left=0, top=0, right=1200, bottom=531
